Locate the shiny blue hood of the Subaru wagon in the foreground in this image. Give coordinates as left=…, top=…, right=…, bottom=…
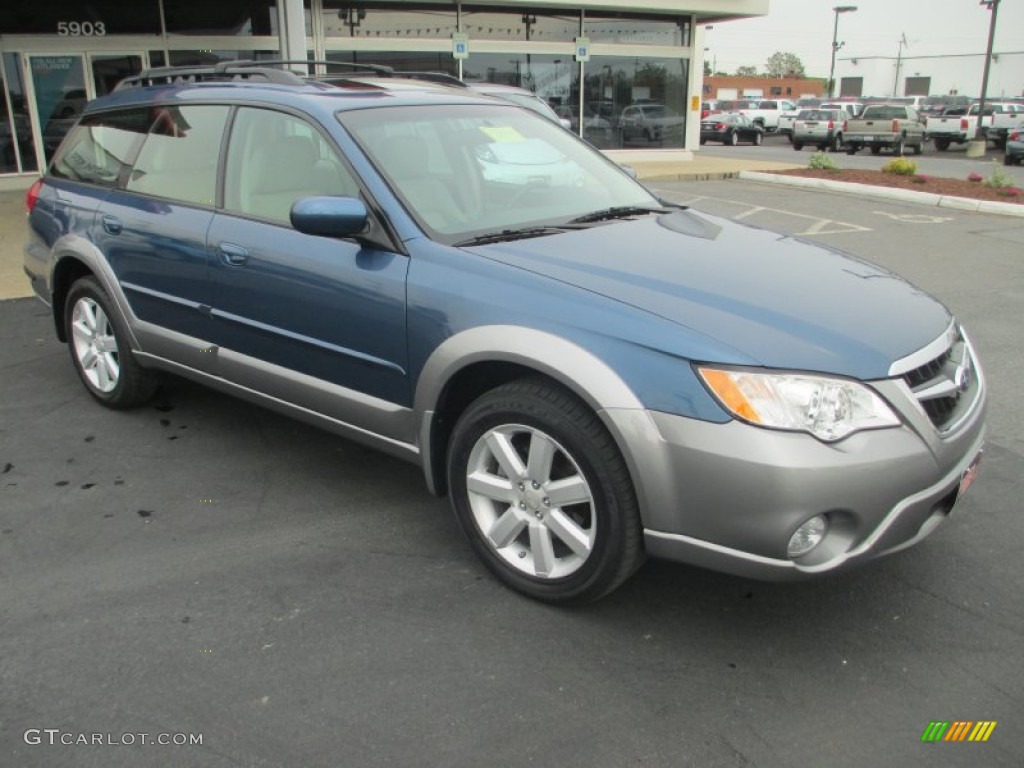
left=469, top=210, right=950, bottom=379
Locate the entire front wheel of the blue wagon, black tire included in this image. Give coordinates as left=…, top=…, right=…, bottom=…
left=447, top=379, right=644, bottom=603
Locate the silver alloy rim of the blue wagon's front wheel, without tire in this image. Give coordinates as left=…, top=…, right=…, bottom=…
left=466, top=424, right=596, bottom=579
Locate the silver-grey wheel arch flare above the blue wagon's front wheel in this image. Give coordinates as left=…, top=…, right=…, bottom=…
left=414, top=326, right=643, bottom=496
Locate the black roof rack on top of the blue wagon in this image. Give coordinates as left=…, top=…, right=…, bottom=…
left=115, top=59, right=394, bottom=90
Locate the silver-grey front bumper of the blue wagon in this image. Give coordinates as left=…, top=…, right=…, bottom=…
left=605, top=376, right=985, bottom=581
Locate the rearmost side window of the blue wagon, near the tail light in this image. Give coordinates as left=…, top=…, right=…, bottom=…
left=50, top=110, right=150, bottom=186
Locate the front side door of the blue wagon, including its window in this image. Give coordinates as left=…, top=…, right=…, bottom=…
left=207, top=106, right=411, bottom=415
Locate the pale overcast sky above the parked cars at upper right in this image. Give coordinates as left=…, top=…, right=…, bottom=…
left=705, top=0, right=1024, bottom=78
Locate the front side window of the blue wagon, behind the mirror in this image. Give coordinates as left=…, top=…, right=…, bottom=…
left=224, top=108, right=359, bottom=224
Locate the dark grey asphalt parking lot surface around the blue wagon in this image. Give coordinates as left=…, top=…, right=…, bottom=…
left=0, top=182, right=1024, bottom=768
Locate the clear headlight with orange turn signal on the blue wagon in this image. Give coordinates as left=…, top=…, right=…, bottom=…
left=697, top=368, right=900, bottom=441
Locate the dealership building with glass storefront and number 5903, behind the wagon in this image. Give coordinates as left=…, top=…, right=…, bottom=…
left=0, top=0, right=768, bottom=186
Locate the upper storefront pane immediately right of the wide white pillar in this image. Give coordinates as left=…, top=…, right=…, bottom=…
left=321, top=0, right=457, bottom=39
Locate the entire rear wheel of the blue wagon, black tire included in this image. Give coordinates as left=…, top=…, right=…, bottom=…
left=63, top=276, right=160, bottom=409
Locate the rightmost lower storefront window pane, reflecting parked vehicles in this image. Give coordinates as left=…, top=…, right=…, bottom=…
left=583, top=56, right=688, bottom=148
